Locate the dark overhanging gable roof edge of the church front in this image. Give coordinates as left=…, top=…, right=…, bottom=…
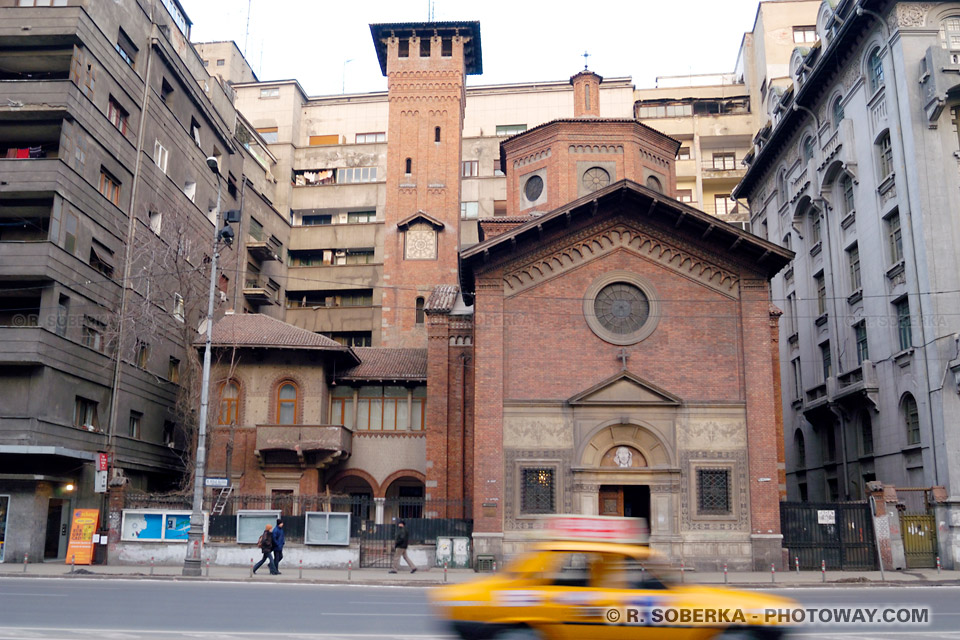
left=460, top=180, right=794, bottom=291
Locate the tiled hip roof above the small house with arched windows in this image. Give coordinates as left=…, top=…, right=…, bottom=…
left=206, top=313, right=349, bottom=351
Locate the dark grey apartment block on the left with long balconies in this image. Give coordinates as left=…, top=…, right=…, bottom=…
left=0, top=0, right=289, bottom=561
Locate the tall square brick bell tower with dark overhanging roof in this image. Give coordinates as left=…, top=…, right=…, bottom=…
left=370, top=22, right=483, bottom=347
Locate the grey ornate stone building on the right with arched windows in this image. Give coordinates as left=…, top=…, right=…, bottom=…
left=735, top=1, right=960, bottom=562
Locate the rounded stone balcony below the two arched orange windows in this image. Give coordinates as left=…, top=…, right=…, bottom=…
left=254, top=424, right=353, bottom=469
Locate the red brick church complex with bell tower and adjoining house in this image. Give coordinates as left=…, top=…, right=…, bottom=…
left=208, top=22, right=791, bottom=569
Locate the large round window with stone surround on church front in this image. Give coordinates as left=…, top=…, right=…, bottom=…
left=583, top=271, right=660, bottom=345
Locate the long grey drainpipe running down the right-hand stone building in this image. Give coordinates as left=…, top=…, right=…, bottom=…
left=856, top=0, right=940, bottom=485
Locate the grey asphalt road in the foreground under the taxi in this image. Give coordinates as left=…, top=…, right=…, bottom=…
left=0, top=578, right=960, bottom=640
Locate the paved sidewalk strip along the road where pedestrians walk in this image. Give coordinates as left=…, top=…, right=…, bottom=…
left=0, top=562, right=960, bottom=588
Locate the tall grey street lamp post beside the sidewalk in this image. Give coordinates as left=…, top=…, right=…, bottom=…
left=183, top=157, right=221, bottom=576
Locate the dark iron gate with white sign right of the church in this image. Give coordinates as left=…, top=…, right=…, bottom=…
left=780, top=502, right=877, bottom=571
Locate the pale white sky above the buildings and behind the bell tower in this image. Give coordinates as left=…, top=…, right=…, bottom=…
left=181, top=0, right=757, bottom=95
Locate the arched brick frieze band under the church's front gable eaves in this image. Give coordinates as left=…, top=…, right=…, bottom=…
left=503, top=222, right=740, bottom=299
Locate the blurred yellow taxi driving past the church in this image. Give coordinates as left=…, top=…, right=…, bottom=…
left=429, top=518, right=798, bottom=640
